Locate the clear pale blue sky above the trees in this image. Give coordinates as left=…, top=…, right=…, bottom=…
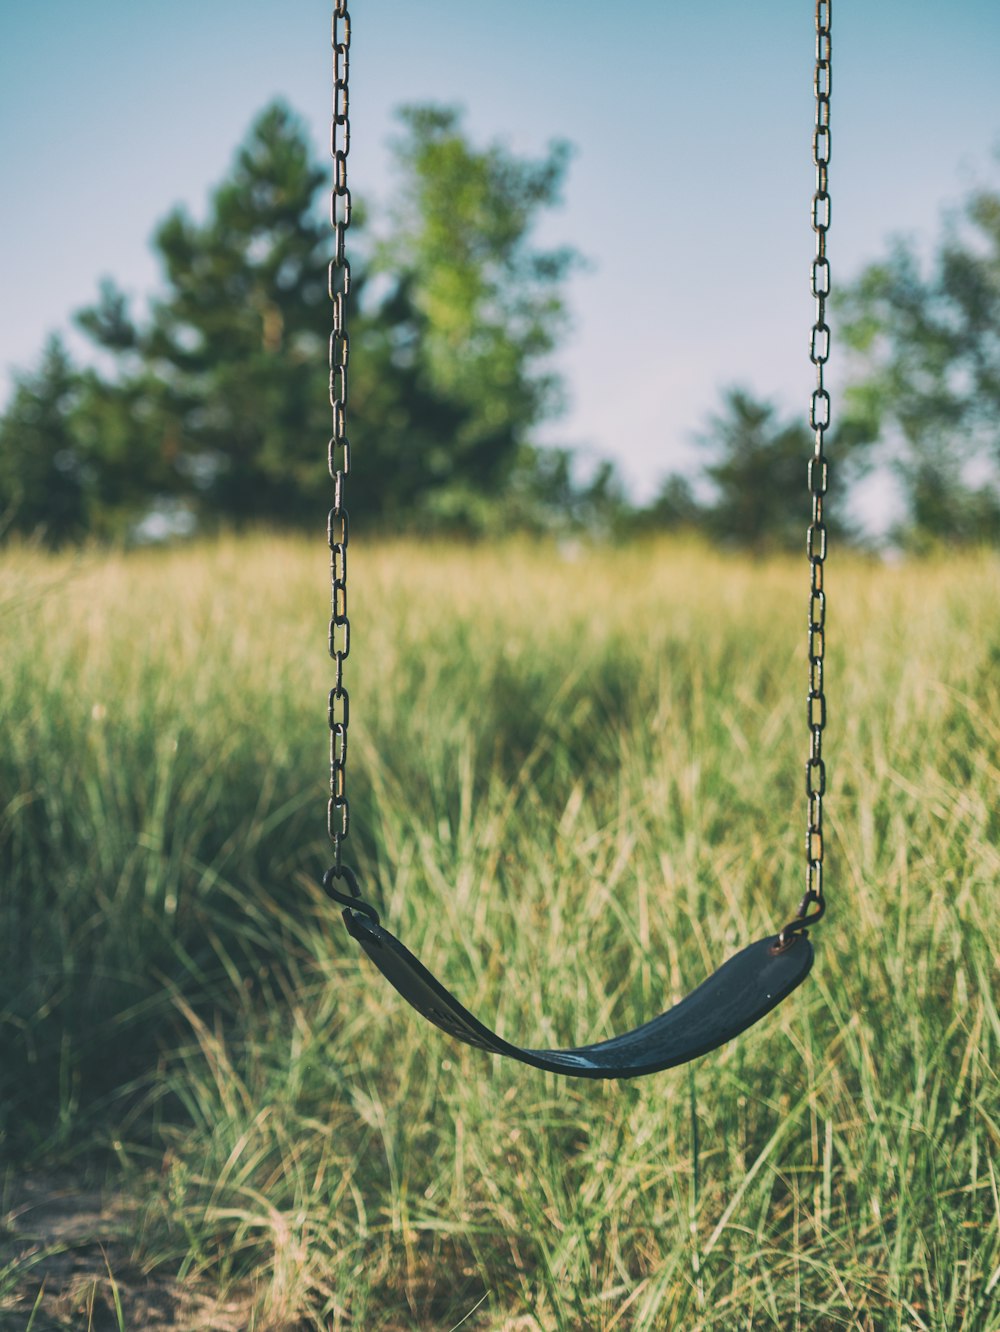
left=0, top=0, right=1000, bottom=522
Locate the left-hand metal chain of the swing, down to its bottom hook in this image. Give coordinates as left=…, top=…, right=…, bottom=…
left=324, top=0, right=358, bottom=898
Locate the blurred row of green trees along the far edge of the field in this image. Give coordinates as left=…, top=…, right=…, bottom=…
left=0, top=103, right=1000, bottom=547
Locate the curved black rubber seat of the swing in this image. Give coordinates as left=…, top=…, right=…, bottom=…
left=336, top=895, right=812, bottom=1078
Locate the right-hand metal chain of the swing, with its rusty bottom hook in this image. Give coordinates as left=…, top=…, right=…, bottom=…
left=778, top=0, right=832, bottom=950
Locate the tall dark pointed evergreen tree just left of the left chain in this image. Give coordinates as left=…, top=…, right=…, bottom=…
left=79, top=104, right=329, bottom=522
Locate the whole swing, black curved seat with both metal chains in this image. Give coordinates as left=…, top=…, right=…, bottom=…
left=324, top=0, right=832, bottom=1078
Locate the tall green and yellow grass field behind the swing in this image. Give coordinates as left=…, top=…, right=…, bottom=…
left=0, top=537, right=1000, bottom=1332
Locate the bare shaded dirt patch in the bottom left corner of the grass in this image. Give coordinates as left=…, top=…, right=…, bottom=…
left=0, top=1175, right=252, bottom=1332
